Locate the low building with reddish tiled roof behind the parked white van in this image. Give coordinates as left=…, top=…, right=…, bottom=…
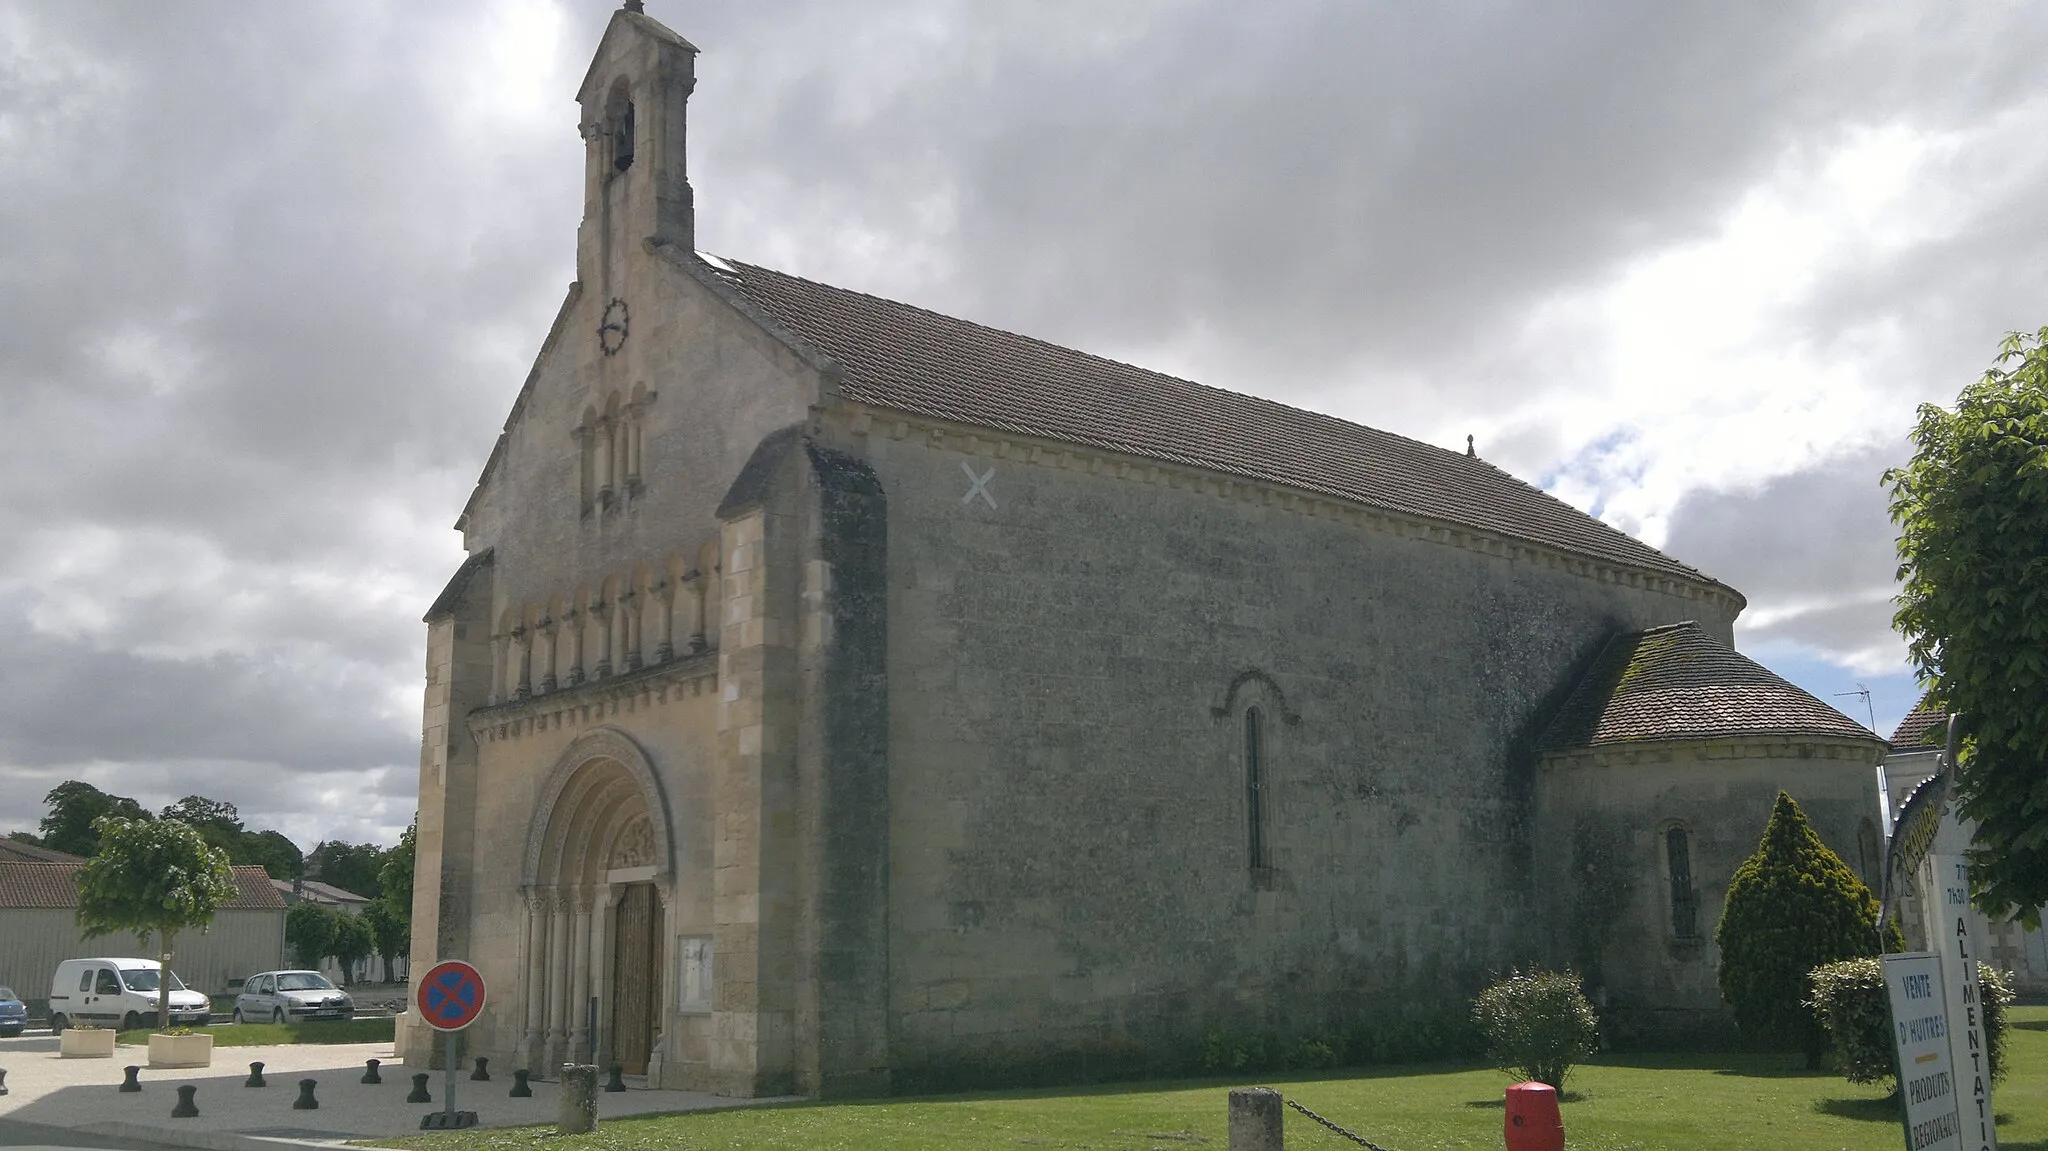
left=0, top=852, right=285, bottom=1014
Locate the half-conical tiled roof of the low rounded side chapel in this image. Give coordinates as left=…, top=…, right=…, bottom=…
left=1542, top=623, right=1878, bottom=750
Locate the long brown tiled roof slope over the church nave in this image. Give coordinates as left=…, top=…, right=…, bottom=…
left=707, top=256, right=1712, bottom=584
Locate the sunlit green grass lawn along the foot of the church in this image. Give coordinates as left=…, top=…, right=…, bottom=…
left=379, top=1008, right=2048, bottom=1151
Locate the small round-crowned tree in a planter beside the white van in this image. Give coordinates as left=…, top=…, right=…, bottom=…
left=78, top=813, right=240, bottom=1028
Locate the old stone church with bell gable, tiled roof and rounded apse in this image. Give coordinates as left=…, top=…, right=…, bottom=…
left=408, top=0, right=1884, bottom=1096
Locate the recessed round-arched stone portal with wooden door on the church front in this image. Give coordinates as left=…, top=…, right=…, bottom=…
left=520, top=727, right=674, bottom=1073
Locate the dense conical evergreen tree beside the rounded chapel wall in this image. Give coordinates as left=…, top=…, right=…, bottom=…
left=1714, top=791, right=1905, bottom=1067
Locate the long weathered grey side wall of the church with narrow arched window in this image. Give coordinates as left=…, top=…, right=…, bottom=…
left=823, top=414, right=1737, bottom=1085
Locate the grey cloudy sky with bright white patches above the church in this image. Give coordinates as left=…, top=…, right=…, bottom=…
left=0, top=0, right=2048, bottom=846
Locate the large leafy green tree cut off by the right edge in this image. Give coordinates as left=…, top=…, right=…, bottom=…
left=1884, top=328, right=2048, bottom=928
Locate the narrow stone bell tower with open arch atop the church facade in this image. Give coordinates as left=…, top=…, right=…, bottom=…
left=575, top=0, right=696, bottom=290
